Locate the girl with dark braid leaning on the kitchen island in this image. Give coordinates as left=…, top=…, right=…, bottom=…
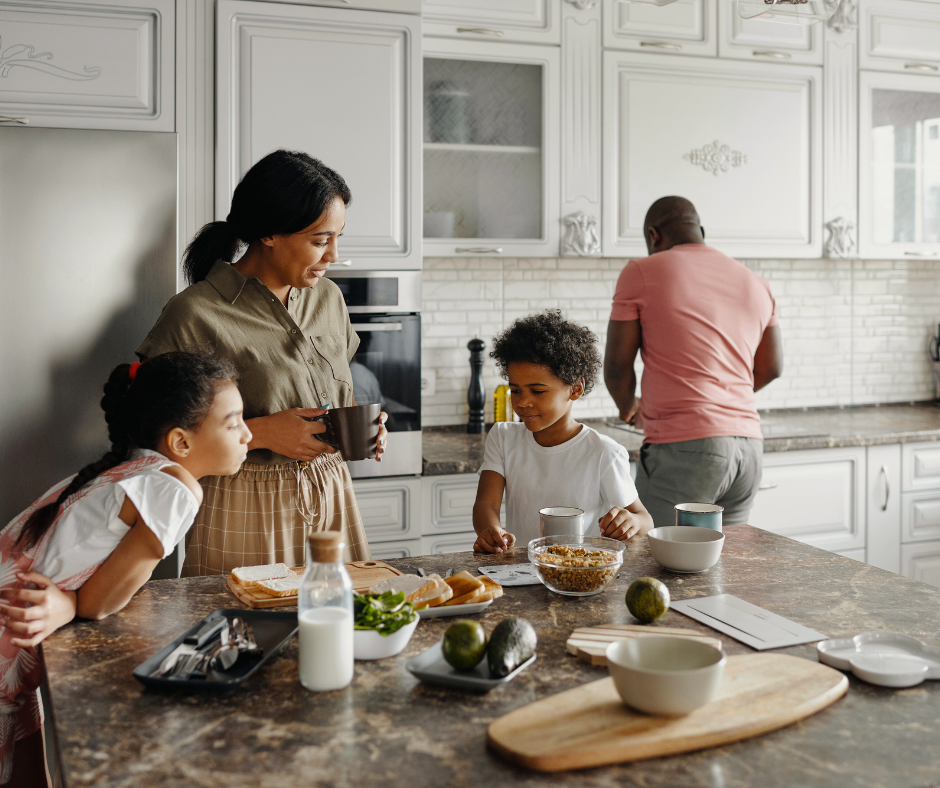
left=0, top=352, right=251, bottom=786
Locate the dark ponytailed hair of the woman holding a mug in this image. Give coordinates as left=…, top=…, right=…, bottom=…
left=183, top=150, right=352, bottom=284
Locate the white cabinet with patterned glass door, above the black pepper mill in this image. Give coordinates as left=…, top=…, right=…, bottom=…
left=423, top=39, right=560, bottom=257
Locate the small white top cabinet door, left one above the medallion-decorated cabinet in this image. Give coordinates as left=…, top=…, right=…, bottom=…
left=603, top=0, right=716, bottom=57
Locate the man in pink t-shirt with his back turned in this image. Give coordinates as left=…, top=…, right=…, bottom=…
left=604, top=197, right=783, bottom=527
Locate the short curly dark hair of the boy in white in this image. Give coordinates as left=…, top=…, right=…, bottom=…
left=490, top=309, right=601, bottom=394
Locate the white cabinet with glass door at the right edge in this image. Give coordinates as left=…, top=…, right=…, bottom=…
left=859, top=72, right=940, bottom=259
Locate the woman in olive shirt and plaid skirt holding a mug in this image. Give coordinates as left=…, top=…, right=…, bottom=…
left=137, top=150, right=386, bottom=577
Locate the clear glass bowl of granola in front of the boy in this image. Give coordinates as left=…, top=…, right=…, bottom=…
left=529, top=534, right=626, bottom=596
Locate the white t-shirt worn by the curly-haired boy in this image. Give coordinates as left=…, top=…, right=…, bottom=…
left=479, top=422, right=637, bottom=546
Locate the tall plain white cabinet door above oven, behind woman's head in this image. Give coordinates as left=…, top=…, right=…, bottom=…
left=216, top=0, right=421, bottom=270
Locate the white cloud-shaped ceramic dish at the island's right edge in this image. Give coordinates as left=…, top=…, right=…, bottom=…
left=816, top=632, right=940, bottom=687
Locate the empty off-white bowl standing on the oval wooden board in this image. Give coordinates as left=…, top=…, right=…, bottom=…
left=607, top=635, right=725, bottom=717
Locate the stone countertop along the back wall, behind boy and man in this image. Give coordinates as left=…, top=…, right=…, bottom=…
left=422, top=402, right=940, bottom=476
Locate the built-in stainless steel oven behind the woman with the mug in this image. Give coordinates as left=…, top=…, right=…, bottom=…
left=328, top=269, right=421, bottom=479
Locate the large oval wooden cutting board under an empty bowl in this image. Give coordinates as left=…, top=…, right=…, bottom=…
left=487, top=654, right=849, bottom=772
